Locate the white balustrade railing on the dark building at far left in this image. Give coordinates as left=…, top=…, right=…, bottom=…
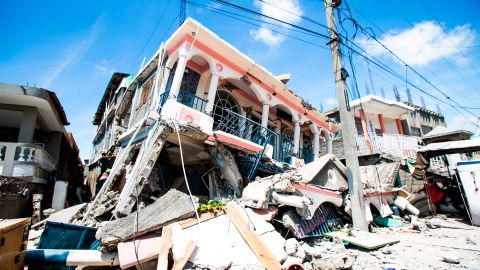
left=0, top=142, right=57, bottom=176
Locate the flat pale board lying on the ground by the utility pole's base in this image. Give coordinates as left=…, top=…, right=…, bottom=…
left=324, top=231, right=400, bottom=250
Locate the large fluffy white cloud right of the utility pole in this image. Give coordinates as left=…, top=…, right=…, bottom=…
left=359, top=21, right=475, bottom=66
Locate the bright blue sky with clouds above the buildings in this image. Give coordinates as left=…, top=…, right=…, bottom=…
left=0, top=0, right=480, bottom=158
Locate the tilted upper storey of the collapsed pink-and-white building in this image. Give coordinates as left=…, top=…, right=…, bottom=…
left=89, top=19, right=331, bottom=196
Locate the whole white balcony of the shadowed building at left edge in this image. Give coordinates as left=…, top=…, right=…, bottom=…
left=0, top=142, right=57, bottom=183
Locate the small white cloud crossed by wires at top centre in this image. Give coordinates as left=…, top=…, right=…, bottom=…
left=250, top=0, right=303, bottom=47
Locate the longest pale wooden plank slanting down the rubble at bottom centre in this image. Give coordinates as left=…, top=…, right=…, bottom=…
left=225, top=201, right=282, bottom=270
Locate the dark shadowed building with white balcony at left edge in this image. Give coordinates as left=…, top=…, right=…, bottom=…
left=0, top=83, right=83, bottom=217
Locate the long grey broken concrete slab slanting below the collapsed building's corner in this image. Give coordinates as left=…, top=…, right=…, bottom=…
left=96, top=189, right=198, bottom=245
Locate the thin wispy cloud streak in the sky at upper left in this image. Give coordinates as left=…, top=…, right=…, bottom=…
left=41, top=16, right=103, bottom=88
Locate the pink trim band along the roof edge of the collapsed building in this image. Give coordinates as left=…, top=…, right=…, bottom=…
left=168, top=34, right=331, bottom=131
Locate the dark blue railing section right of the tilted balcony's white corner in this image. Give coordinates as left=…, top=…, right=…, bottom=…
left=213, top=107, right=275, bottom=146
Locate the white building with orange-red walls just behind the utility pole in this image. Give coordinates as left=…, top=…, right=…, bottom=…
left=325, top=95, right=452, bottom=159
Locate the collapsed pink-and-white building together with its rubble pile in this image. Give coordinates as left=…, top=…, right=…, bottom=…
left=18, top=19, right=426, bottom=269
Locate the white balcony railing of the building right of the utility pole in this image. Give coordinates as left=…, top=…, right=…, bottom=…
left=356, top=133, right=418, bottom=158
